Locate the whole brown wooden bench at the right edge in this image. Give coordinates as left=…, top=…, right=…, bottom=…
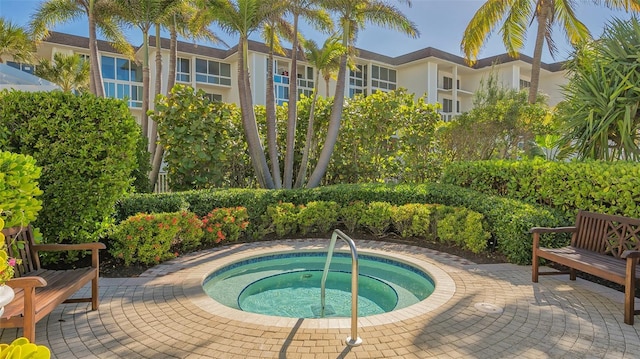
left=531, top=211, right=640, bottom=325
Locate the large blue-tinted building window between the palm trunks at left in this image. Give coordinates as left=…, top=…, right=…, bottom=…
left=101, top=56, right=142, bottom=108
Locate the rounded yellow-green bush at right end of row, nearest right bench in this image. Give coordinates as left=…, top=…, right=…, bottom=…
left=437, top=208, right=491, bottom=253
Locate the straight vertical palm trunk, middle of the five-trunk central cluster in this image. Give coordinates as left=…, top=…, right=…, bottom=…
left=284, top=13, right=298, bottom=189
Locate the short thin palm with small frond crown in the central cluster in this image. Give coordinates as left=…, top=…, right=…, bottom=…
left=294, top=35, right=345, bottom=188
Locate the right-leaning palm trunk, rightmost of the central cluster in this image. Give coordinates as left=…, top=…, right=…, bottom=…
left=307, top=50, right=349, bottom=188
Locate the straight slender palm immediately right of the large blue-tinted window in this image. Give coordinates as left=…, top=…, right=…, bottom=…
left=115, top=0, right=181, bottom=145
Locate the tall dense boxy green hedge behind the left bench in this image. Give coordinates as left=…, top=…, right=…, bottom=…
left=0, top=91, right=141, bottom=248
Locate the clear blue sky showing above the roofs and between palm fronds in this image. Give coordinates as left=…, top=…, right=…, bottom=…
left=0, top=0, right=630, bottom=63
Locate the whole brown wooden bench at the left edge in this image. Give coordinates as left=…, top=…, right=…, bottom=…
left=0, top=227, right=105, bottom=343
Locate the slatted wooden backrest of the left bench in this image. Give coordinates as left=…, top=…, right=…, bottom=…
left=2, top=226, right=40, bottom=277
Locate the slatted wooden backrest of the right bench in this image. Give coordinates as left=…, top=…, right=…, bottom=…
left=571, top=211, right=640, bottom=258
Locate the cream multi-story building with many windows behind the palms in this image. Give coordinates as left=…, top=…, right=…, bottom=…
left=4, top=32, right=567, bottom=120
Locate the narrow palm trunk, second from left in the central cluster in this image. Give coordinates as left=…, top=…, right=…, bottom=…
left=265, top=30, right=282, bottom=189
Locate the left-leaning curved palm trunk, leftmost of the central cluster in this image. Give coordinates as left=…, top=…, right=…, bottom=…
left=238, top=35, right=275, bottom=189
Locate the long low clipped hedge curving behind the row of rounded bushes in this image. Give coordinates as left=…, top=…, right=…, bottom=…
left=116, top=184, right=569, bottom=264
